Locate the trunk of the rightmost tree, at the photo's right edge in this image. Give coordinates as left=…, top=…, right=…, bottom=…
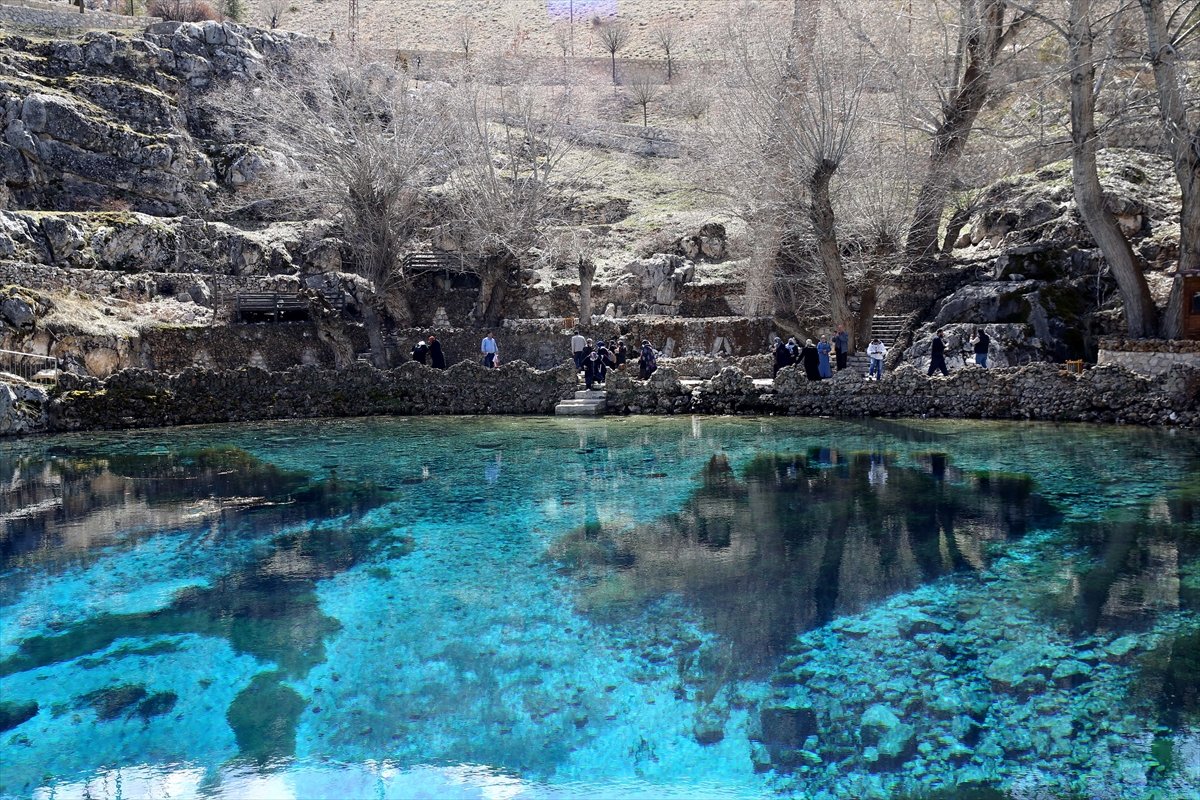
left=1141, top=0, right=1200, bottom=338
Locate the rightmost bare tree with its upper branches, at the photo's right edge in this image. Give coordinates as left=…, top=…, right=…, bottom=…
left=1141, top=0, right=1200, bottom=338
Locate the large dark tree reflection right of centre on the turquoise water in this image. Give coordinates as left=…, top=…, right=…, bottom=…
left=554, top=449, right=1061, bottom=673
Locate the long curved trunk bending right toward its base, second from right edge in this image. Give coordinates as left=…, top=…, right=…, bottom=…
left=1068, top=0, right=1157, bottom=338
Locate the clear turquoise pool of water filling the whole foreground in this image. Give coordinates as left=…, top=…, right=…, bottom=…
left=0, top=419, right=1200, bottom=798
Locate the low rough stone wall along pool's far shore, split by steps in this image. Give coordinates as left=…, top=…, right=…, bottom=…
left=0, top=361, right=1200, bottom=434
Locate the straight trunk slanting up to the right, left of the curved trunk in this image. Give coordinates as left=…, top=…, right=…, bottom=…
left=905, top=0, right=1006, bottom=263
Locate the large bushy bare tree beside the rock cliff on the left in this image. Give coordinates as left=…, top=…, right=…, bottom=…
left=218, top=50, right=440, bottom=367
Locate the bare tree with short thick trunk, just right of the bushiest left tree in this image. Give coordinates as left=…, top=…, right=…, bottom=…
left=446, top=74, right=581, bottom=325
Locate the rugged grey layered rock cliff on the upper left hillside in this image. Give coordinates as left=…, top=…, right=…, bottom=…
left=0, top=23, right=313, bottom=215
